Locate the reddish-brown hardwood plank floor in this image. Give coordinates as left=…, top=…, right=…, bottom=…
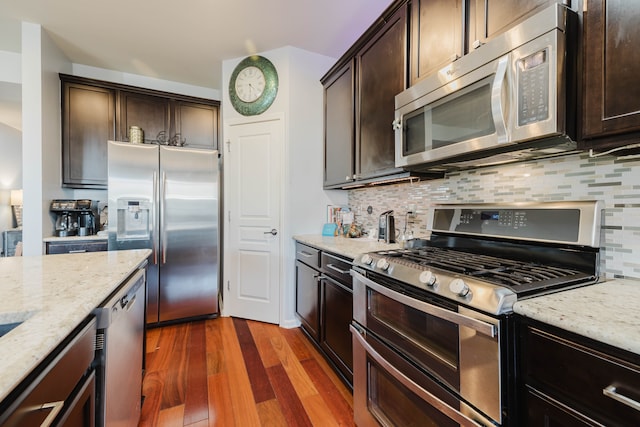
left=139, top=317, right=354, bottom=427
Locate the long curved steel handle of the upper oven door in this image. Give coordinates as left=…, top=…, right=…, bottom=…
left=351, top=270, right=496, bottom=338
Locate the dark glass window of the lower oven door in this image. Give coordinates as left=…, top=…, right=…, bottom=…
left=367, top=360, right=458, bottom=427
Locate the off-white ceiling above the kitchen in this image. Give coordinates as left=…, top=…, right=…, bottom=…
left=0, top=0, right=391, bottom=90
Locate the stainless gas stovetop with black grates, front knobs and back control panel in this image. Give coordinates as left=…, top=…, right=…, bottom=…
left=354, top=202, right=601, bottom=315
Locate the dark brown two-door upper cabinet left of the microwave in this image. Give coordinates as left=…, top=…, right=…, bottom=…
left=321, top=3, right=408, bottom=188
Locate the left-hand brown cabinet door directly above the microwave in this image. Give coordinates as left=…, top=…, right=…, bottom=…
left=410, top=0, right=464, bottom=85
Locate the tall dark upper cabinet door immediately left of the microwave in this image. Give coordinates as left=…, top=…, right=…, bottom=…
left=356, top=5, right=407, bottom=179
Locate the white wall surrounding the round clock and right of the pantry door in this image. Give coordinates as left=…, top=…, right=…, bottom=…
left=222, top=47, right=347, bottom=327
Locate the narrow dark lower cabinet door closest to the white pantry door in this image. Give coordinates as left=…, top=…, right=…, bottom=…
left=296, top=261, right=320, bottom=342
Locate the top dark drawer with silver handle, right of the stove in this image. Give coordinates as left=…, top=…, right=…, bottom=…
left=523, top=327, right=640, bottom=425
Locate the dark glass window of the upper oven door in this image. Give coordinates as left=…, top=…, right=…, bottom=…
left=367, top=289, right=460, bottom=389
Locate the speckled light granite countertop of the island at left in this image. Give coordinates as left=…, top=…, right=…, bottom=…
left=0, top=249, right=151, bottom=401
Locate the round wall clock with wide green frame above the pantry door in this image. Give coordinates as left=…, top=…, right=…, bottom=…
left=229, top=55, right=278, bottom=116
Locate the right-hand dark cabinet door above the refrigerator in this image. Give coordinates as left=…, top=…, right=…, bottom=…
left=172, top=101, right=218, bottom=149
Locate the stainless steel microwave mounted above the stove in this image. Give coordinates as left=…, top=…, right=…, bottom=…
left=393, top=4, right=577, bottom=171
